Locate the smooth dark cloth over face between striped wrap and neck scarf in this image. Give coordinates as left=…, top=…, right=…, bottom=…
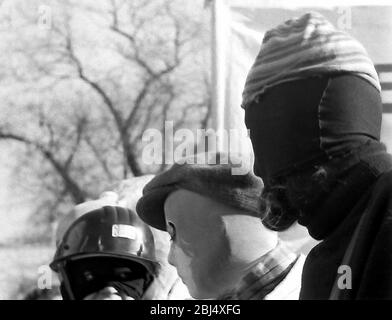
left=245, top=74, right=382, bottom=184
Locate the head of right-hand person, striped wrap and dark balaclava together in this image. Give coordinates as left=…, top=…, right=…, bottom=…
left=243, top=13, right=382, bottom=230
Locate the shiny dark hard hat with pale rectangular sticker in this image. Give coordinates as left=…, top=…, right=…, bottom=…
left=50, top=206, right=159, bottom=298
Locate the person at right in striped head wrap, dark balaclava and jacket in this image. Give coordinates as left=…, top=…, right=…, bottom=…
left=243, top=13, right=392, bottom=299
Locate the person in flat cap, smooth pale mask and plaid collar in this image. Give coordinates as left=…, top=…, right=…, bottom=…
left=136, top=153, right=304, bottom=300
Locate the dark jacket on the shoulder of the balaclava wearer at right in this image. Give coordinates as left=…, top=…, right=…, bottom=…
left=300, top=152, right=392, bottom=300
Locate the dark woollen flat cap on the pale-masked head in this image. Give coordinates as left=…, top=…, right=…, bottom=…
left=136, top=153, right=263, bottom=230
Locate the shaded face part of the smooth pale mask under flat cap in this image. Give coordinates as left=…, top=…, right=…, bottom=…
left=165, top=190, right=230, bottom=299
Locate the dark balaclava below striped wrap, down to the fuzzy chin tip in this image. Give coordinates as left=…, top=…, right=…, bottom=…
left=246, top=74, right=382, bottom=231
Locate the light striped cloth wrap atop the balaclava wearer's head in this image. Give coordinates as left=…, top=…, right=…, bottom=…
left=242, top=12, right=381, bottom=108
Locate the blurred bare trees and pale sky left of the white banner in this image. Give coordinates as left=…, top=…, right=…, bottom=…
left=0, top=0, right=211, bottom=299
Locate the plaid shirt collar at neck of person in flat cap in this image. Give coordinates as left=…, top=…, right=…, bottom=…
left=218, top=243, right=299, bottom=300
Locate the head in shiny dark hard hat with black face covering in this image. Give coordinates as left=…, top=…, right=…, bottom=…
left=51, top=206, right=159, bottom=300
